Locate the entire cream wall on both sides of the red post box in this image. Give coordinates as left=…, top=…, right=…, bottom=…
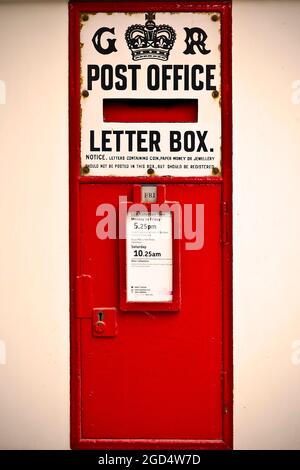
left=0, top=0, right=300, bottom=449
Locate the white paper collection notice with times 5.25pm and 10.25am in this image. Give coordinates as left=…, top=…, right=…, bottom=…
left=126, top=212, right=173, bottom=302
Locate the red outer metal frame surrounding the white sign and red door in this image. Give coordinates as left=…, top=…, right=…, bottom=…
left=69, top=0, right=233, bottom=449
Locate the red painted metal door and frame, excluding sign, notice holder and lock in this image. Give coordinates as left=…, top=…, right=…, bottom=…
left=70, top=2, right=233, bottom=449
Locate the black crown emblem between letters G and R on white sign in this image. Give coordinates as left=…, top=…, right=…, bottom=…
left=125, top=12, right=176, bottom=60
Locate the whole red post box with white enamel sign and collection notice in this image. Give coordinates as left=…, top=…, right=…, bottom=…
left=70, top=1, right=232, bottom=449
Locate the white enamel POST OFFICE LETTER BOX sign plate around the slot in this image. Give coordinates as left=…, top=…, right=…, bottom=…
left=80, top=12, right=221, bottom=177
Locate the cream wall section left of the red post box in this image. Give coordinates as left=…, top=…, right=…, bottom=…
left=0, top=1, right=69, bottom=449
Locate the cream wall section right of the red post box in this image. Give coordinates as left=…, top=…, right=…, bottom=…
left=233, top=0, right=300, bottom=449
